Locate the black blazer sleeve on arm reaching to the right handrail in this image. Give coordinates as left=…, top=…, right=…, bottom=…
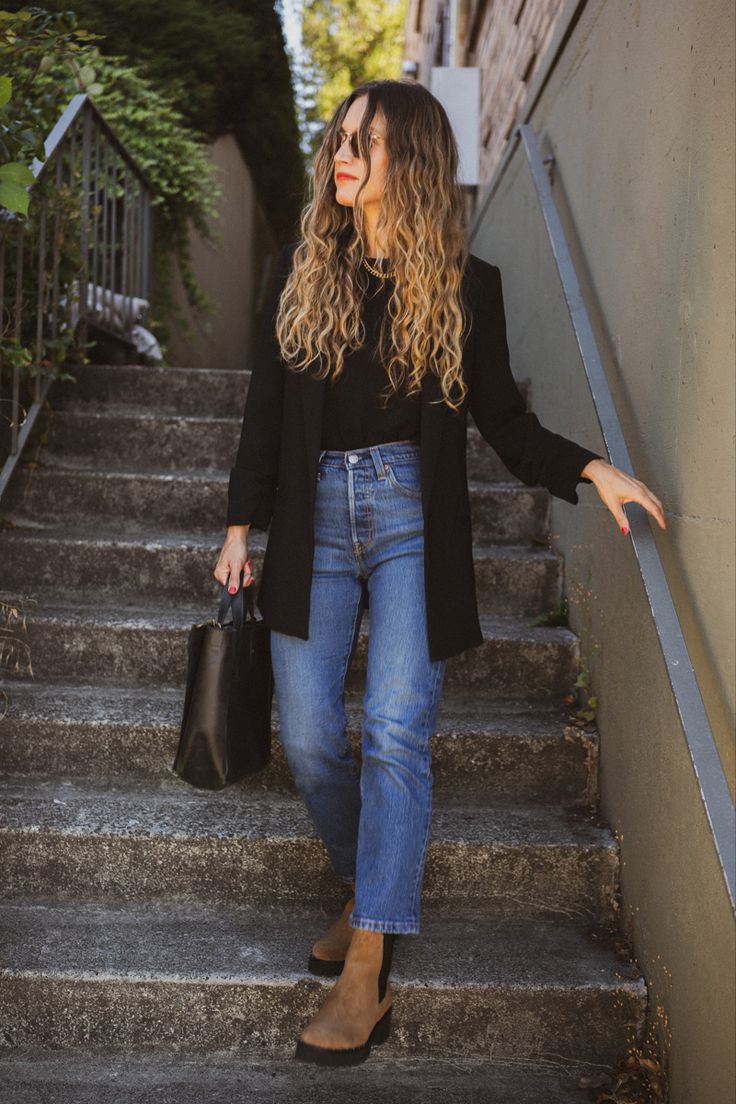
left=468, top=263, right=606, bottom=506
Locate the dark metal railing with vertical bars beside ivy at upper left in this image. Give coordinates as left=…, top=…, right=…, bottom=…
left=0, top=93, right=154, bottom=497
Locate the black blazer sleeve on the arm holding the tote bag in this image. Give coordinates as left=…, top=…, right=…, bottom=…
left=226, top=243, right=296, bottom=530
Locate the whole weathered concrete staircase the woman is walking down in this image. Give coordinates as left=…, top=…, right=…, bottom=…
left=0, top=365, right=646, bottom=1104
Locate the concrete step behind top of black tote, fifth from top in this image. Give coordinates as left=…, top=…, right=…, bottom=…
left=2, top=594, right=579, bottom=699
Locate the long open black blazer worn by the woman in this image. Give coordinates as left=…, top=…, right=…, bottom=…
left=227, top=242, right=605, bottom=659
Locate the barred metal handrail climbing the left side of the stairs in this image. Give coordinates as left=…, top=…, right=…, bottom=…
left=0, top=93, right=156, bottom=498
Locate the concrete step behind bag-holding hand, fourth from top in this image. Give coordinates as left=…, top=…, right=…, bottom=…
left=0, top=519, right=563, bottom=617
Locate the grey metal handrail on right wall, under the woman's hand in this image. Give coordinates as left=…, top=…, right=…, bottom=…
left=518, top=123, right=736, bottom=909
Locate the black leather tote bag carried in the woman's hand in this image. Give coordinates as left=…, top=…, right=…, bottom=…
left=172, top=572, right=274, bottom=789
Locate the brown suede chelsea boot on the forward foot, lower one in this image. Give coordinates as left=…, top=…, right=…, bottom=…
left=295, top=927, right=395, bottom=1065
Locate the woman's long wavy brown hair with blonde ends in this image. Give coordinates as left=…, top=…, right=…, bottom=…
left=276, top=79, right=471, bottom=410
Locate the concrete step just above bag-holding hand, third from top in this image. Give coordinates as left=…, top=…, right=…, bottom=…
left=2, top=460, right=550, bottom=545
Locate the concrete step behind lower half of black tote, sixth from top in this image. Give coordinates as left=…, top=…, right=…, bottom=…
left=0, top=682, right=598, bottom=806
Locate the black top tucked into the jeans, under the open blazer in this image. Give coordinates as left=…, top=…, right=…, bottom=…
left=321, top=257, right=420, bottom=452
